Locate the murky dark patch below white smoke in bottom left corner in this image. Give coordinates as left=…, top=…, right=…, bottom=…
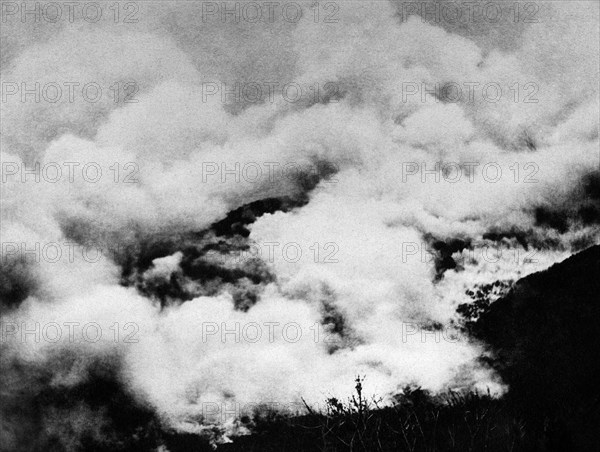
left=1, top=350, right=160, bottom=452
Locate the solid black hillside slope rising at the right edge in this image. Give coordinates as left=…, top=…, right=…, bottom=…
left=467, top=246, right=600, bottom=450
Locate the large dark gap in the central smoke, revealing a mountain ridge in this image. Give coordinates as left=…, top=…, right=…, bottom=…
left=122, top=196, right=310, bottom=311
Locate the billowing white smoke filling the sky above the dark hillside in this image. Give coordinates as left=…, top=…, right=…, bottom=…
left=0, top=1, right=599, bottom=450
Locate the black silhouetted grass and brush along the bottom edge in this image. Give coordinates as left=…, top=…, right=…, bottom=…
left=218, top=378, right=542, bottom=452
